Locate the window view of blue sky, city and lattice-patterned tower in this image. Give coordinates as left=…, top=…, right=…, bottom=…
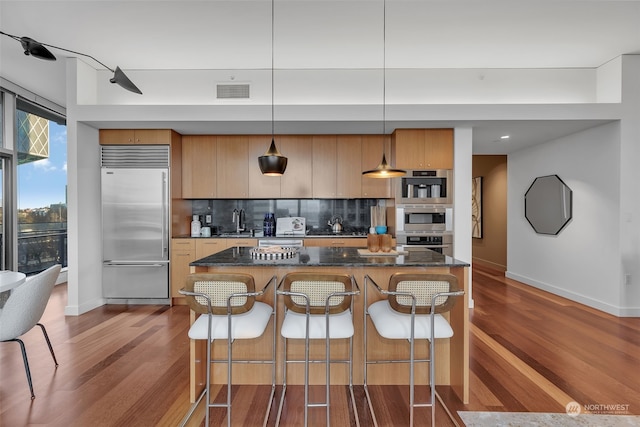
left=16, top=111, right=67, bottom=274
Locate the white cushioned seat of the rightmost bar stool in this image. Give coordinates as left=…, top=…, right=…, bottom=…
left=369, top=299, right=453, bottom=340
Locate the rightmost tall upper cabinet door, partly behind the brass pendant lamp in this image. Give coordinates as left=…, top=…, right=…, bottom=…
left=360, top=135, right=395, bottom=199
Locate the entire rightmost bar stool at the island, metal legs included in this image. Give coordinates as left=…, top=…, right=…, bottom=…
left=364, top=273, right=464, bottom=426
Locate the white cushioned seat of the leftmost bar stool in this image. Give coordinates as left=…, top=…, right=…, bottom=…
left=189, top=301, right=272, bottom=341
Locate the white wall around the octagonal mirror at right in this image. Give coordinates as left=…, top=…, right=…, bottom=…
left=506, top=123, right=622, bottom=314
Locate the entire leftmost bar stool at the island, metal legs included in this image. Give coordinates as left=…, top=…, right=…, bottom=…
left=179, top=273, right=277, bottom=427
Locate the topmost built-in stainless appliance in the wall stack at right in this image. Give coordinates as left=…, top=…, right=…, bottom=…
left=396, top=169, right=453, bottom=205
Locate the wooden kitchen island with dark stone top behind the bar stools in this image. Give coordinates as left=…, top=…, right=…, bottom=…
left=190, top=247, right=469, bottom=403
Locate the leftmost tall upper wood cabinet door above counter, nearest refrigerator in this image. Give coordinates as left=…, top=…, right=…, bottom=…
left=182, top=135, right=217, bottom=199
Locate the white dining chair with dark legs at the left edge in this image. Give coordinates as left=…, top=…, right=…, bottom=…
left=0, top=265, right=61, bottom=399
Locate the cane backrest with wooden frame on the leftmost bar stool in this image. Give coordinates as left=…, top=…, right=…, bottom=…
left=185, top=273, right=256, bottom=314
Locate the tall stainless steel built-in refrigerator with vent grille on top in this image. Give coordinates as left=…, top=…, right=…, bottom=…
left=101, top=146, right=170, bottom=303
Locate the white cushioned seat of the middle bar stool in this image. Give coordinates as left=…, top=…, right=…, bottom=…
left=280, top=310, right=353, bottom=339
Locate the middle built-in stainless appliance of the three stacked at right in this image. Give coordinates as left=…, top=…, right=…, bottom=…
left=396, top=205, right=453, bottom=233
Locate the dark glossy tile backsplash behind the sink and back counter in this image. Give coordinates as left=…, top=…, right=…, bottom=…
left=190, top=199, right=378, bottom=233
